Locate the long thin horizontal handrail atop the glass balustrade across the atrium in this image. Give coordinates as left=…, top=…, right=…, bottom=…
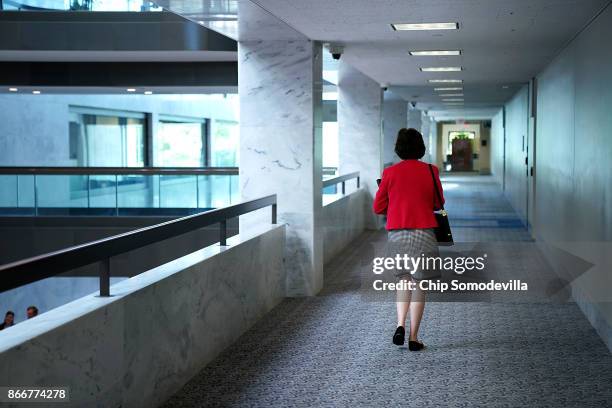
left=0, top=167, right=238, bottom=176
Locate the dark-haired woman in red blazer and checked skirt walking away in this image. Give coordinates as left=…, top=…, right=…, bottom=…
left=374, top=129, right=444, bottom=351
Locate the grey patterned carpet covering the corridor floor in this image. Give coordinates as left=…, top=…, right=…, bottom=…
left=166, top=177, right=612, bottom=407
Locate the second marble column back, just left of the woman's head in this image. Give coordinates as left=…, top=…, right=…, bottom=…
left=338, top=61, right=383, bottom=229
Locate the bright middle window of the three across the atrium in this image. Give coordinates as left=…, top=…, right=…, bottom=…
left=153, top=116, right=207, bottom=167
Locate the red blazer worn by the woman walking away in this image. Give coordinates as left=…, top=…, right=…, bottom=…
left=374, top=160, right=444, bottom=230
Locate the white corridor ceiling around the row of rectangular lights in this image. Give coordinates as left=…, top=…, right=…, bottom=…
left=251, top=0, right=610, bottom=117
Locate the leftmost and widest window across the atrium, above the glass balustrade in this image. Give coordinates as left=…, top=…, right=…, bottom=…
left=69, top=107, right=146, bottom=167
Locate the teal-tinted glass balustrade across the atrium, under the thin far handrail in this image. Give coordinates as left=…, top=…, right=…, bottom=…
left=0, top=174, right=234, bottom=216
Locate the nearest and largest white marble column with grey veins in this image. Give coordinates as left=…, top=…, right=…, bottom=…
left=238, top=32, right=323, bottom=296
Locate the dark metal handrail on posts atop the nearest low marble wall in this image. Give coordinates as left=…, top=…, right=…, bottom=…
left=0, top=194, right=276, bottom=296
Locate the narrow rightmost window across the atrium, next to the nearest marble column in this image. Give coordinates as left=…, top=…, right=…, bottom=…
left=210, top=120, right=240, bottom=167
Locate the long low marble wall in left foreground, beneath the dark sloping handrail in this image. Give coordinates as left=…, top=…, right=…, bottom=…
left=0, top=225, right=285, bottom=408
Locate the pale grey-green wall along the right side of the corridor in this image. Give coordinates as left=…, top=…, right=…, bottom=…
left=492, top=1, right=612, bottom=350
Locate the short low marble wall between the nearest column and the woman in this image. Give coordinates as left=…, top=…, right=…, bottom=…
left=323, top=188, right=366, bottom=264
